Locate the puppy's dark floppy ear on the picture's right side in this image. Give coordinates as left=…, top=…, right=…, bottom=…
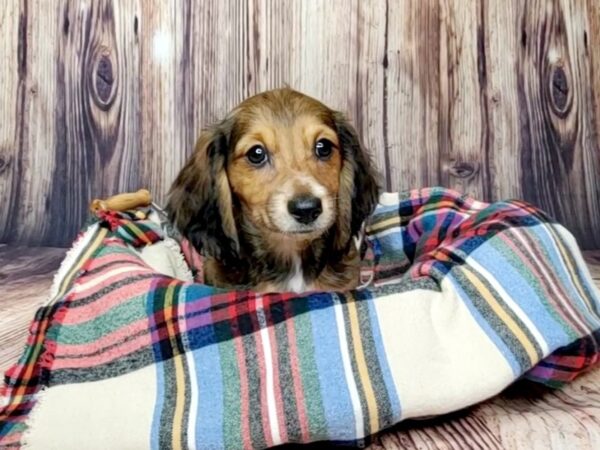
left=333, top=112, right=379, bottom=251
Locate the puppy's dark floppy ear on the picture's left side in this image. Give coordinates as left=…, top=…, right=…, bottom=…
left=167, top=123, right=239, bottom=263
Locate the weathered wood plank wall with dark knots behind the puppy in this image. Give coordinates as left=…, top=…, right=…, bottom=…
left=0, top=0, right=600, bottom=248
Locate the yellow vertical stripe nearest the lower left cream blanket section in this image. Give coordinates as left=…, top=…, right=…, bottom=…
left=165, top=284, right=185, bottom=450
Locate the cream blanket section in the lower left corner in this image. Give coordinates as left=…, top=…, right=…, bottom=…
left=25, top=366, right=156, bottom=450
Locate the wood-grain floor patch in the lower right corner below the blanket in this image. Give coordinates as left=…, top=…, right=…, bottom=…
left=368, top=368, right=600, bottom=450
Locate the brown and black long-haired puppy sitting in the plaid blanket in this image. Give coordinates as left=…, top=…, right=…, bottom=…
left=167, top=89, right=378, bottom=292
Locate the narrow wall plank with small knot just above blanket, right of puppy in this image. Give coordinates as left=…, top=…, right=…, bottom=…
left=439, top=1, right=490, bottom=198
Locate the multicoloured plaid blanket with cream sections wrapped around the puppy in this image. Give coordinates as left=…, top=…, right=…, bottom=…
left=0, top=188, right=600, bottom=450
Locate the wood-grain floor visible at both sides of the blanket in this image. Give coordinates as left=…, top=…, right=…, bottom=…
left=0, top=245, right=600, bottom=450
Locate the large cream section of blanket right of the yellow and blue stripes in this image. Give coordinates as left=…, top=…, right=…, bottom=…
left=374, top=288, right=514, bottom=419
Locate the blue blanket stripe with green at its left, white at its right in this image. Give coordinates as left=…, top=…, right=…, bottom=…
left=307, top=294, right=362, bottom=441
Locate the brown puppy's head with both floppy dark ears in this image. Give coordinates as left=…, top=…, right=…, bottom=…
left=168, top=89, right=378, bottom=262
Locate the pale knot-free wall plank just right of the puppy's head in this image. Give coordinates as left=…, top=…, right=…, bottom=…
left=381, top=0, right=445, bottom=190
